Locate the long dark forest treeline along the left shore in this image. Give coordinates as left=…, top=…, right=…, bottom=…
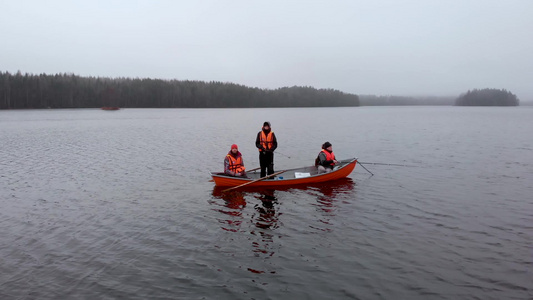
left=0, top=72, right=359, bottom=109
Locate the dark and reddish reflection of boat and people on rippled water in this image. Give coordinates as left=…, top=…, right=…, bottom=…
left=211, top=178, right=355, bottom=273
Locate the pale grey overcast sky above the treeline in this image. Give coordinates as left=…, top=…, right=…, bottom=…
left=0, top=0, right=533, bottom=101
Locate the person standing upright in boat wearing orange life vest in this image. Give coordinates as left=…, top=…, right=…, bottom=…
left=255, top=122, right=278, bottom=177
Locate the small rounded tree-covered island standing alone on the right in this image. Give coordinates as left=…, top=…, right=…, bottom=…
left=455, top=89, right=520, bottom=106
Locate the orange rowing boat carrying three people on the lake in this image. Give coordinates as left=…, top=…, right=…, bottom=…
left=211, top=158, right=357, bottom=187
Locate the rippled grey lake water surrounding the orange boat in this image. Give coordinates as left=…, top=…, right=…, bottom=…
left=0, top=107, right=533, bottom=299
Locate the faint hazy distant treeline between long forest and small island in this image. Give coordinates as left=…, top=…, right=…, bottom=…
left=359, top=95, right=455, bottom=106
